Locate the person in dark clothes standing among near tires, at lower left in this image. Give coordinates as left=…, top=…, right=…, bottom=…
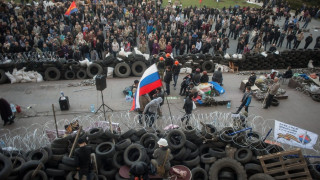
left=74, top=138, right=93, bottom=180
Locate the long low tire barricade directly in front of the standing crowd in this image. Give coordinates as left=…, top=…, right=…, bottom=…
left=0, top=49, right=320, bottom=84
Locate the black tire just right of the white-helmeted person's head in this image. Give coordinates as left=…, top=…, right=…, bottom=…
left=166, top=129, right=186, bottom=149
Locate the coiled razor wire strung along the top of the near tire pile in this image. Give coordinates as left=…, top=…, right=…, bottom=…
left=0, top=111, right=320, bottom=159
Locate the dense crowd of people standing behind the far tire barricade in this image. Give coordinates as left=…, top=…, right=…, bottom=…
left=0, top=0, right=320, bottom=60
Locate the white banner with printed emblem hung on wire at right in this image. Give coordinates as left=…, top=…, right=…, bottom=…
left=274, top=120, right=318, bottom=149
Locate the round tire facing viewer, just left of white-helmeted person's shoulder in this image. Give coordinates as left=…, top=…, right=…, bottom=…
left=123, top=143, right=147, bottom=166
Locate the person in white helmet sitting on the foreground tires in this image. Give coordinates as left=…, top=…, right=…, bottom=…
left=151, top=138, right=173, bottom=178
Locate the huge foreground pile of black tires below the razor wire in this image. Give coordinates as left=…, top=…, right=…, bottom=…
left=0, top=124, right=310, bottom=180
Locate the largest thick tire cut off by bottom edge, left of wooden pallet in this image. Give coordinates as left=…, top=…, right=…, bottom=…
left=209, top=158, right=247, bottom=180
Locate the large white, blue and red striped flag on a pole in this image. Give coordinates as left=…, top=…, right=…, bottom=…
left=131, top=64, right=162, bottom=111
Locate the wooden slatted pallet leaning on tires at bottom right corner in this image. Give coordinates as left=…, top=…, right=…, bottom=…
left=258, top=149, right=312, bottom=180
